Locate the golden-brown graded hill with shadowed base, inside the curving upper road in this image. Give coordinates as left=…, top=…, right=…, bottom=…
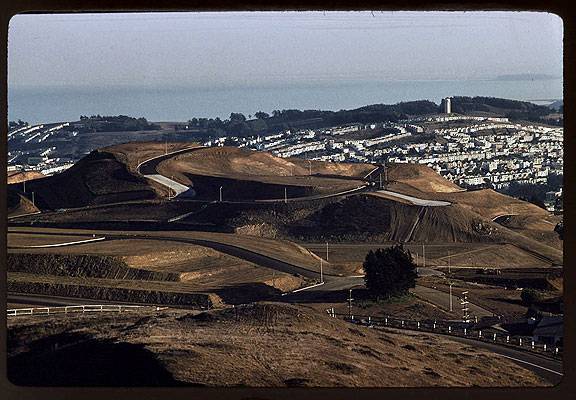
left=158, top=147, right=366, bottom=200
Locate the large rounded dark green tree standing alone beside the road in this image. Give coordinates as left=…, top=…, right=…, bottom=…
left=363, top=244, right=418, bottom=299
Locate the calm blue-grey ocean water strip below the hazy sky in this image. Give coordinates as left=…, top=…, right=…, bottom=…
left=8, top=79, right=563, bottom=123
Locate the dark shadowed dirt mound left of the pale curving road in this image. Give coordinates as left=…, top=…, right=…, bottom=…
left=10, top=151, right=164, bottom=209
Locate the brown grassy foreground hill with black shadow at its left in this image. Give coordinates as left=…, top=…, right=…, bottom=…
left=8, top=303, right=546, bottom=387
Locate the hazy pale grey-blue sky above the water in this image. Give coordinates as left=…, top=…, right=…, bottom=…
left=8, top=12, right=563, bottom=87
